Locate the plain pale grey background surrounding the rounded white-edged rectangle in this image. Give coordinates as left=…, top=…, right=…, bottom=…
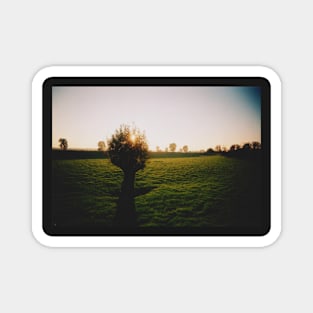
left=0, top=0, right=313, bottom=313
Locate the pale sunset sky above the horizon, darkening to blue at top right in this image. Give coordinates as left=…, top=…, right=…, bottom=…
left=52, top=86, right=261, bottom=151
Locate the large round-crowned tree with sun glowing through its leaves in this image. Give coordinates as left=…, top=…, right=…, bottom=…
left=108, top=125, right=148, bottom=198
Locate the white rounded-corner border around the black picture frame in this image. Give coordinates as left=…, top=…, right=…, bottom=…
left=32, top=66, right=281, bottom=247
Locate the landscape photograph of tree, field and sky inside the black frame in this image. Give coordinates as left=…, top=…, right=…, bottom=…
left=44, top=84, right=269, bottom=235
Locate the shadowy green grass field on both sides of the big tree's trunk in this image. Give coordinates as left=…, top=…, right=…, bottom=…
left=52, top=155, right=261, bottom=228
